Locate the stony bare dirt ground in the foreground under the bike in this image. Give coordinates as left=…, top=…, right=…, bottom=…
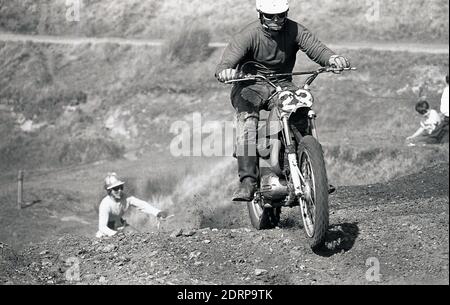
left=0, top=163, right=449, bottom=285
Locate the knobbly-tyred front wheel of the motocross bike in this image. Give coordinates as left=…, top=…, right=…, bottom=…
left=297, top=136, right=329, bottom=250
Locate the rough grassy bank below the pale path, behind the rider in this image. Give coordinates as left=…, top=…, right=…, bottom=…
left=0, top=32, right=448, bottom=184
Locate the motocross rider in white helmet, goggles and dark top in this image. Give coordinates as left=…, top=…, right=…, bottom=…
left=215, top=0, right=350, bottom=201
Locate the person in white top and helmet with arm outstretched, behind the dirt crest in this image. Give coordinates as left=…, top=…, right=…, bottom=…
left=95, top=173, right=168, bottom=238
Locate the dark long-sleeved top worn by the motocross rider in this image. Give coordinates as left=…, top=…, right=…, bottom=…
left=216, top=19, right=335, bottom=77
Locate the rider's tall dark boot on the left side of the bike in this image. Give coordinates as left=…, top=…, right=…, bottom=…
left=232, top=156, right=258, bottom=201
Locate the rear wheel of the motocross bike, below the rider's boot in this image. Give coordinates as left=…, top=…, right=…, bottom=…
left=247, top=196, right=281, bottom=230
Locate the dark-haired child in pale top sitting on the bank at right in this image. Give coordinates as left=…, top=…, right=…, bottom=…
left=406, top=100, right=442, bottom=146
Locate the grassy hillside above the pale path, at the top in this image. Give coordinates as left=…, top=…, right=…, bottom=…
left=0, top=0, right=449, bottom=43
